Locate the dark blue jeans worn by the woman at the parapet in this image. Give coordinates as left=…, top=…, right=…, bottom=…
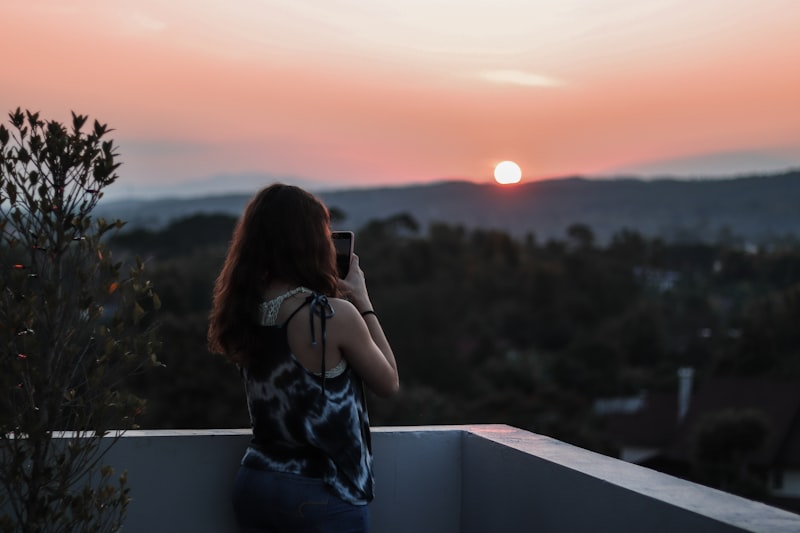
left=233, top=466, right=369, bottom=533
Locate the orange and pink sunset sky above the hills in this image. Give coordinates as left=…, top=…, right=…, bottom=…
left=0, top=0, right=800, bottom=194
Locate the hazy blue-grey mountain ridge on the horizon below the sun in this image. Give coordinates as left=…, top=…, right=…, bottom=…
left=97, top=170, right=800, bottom=242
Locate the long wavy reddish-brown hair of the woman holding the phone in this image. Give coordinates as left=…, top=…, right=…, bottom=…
left=208, top=183, right=338, bottom=366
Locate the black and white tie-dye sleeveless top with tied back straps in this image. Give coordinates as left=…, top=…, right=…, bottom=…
left=242, top=288, right=373, bottom=505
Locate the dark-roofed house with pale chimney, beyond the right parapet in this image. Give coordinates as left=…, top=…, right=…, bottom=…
left=595, top=369, right=800, bottom=512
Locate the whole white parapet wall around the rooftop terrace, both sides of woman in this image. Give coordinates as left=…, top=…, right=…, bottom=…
left=84, top=425, right=800, bottom=533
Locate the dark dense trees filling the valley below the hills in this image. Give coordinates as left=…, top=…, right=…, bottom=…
left=111, top=208, right=800, bottom=458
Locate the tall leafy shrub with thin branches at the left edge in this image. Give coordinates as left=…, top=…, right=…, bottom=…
left=0, top=109, right=159, bottom=532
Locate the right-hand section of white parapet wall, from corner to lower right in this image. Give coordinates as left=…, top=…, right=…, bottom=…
left=462, top=426, right=800, bottom=533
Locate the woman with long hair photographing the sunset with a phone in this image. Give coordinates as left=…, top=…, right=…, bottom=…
left=209, top=184, right=399, bottom=532
